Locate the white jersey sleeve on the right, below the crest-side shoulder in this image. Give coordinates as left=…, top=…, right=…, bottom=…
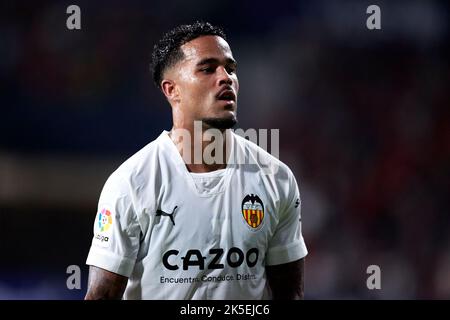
left=266, top=171, right=308, bottom=265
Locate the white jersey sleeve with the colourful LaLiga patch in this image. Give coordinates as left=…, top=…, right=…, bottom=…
left=86, top=172, right=141, bottom=277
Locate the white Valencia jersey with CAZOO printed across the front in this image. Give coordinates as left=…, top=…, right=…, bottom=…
left=86, top=131, right=307, bottom=300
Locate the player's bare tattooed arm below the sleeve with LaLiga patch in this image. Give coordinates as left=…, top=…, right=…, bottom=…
left=84, top=266, right=128, bottom=300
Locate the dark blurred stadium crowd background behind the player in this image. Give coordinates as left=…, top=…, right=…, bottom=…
left=0, top=0, right=450, bottom=299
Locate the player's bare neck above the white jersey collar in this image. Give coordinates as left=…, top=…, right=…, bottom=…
left=169, top=121, right=231, bottom=173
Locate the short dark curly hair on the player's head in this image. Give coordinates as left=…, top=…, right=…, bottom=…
left=151, top=21, right=226, bottom=88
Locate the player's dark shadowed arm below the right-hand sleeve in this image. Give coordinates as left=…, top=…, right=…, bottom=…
left=266, top=258, right=305, bottom=300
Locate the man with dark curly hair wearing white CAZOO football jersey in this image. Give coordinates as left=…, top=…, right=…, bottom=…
left=86, top=22, right=307, bottom=299
